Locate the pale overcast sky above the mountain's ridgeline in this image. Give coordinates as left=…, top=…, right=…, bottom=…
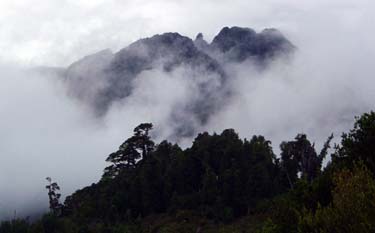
left=0, top=0, right=375, bottom=66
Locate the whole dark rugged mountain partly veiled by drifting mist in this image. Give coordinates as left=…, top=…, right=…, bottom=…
left=64, top=27, right=295, bottom=136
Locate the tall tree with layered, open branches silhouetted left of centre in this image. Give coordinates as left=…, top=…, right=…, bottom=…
left=103, top=123, right=155, bottom=178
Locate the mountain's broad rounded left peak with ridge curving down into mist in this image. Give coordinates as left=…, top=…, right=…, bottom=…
left=103, top=33, right=226, bottom=135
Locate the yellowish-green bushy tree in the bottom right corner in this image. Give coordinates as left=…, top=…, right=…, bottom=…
left=299, top=163, right=375, bottom=233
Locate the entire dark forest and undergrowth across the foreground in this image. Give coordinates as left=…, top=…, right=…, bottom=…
left=0, top=112, right=375, bottom=233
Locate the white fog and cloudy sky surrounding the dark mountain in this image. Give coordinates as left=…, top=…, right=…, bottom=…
left=0, top=0, right=375, bottom=218
